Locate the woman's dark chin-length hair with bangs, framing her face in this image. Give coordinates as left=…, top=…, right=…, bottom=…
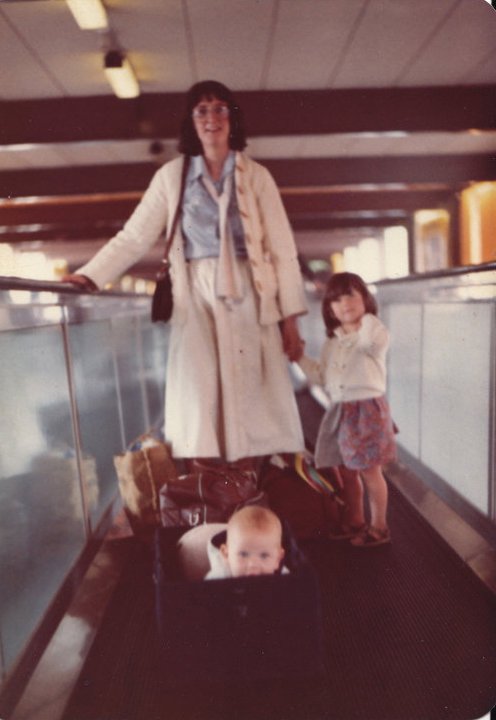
left=179, top=80, right=246, bottom=155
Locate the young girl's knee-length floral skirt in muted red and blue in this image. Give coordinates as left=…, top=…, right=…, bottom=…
left=315, top=396, right=397, bottom=470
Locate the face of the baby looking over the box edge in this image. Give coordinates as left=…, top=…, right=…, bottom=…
left=222, top=527, right=284, bottom=577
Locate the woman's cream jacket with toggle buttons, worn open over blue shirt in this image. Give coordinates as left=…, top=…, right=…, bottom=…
left=77, top=153, right=306, bottom=325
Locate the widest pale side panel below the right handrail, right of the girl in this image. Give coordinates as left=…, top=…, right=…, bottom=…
left=421, top=303, right=492, bottom=514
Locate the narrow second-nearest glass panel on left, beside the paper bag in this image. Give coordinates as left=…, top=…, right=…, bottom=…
left=67, top=320, right=123, bottom=529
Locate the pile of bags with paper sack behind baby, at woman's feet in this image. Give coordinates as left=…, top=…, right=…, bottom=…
left=114, top=432, right=342, bottom=540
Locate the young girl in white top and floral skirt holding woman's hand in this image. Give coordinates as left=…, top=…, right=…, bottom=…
left=298, top=272, right=396, bottom=547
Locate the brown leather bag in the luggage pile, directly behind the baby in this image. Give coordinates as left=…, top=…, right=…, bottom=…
left=160, top=466, right=267, bottom=527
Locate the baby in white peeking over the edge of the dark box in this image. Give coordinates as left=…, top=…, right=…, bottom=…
left=205, top=505, right=287, bottom=580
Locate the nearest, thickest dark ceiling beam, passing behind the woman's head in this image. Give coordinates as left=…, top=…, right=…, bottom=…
left=0, top=85, right=496, bottom=145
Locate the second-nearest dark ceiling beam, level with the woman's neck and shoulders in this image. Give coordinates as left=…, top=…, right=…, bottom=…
left=0, top=154, right=496, bottom=198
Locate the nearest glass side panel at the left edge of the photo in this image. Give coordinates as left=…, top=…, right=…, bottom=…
left=0, top=326, right=85, bottom=671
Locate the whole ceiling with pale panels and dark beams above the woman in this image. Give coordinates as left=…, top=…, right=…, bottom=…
left=0, top=0, right=496, bottom=273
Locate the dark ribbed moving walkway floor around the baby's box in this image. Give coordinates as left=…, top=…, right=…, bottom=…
left=64, top=480, right=496, bottom=720
